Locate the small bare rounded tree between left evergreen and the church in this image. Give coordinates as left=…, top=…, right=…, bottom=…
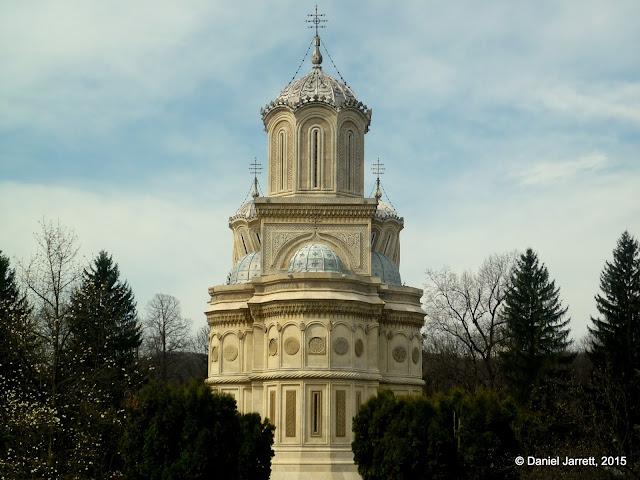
left=144, top=293, right=190, bottom=383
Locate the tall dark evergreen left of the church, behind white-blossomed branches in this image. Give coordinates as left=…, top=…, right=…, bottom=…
left=63, top=251, right=142, bottom=478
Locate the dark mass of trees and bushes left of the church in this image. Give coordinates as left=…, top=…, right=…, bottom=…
left=0, top=222, right=273, bottom=480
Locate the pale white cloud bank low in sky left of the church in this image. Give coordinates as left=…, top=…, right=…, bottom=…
left=0, top=182, right=230, bottom=325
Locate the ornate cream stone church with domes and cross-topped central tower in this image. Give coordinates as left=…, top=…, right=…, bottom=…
left=206, top=16, right=424, bottom=480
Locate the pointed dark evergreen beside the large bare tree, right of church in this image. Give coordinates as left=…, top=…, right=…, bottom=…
left=501, top=248, right=571, bottom=402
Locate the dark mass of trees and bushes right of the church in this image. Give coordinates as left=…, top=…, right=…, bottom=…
left=353, top=232, right=640, bottom=480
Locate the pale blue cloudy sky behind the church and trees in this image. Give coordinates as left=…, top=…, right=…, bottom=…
left=0, top=0, right=640, bottom=339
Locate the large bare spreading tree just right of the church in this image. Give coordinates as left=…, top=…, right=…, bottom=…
left=423, top=252, right=517, bottom=387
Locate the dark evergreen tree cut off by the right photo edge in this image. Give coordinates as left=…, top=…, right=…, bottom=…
left=589, top=231, right=640, bottom=468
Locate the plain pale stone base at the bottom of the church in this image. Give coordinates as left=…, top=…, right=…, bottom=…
left=270, top=447, right=362, bottom=480
